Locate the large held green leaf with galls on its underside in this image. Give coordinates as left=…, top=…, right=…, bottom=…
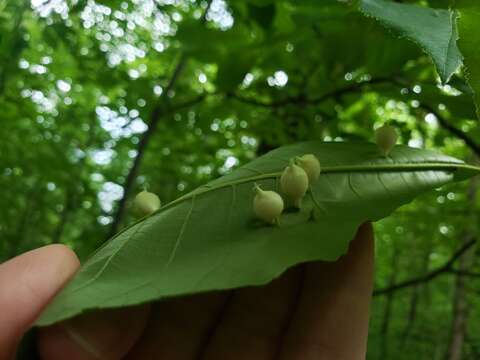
left=37, top=142, right=480, bottom=325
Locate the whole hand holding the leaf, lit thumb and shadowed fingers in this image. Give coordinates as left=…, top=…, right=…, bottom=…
left=0, top=223, right=374, bottom=360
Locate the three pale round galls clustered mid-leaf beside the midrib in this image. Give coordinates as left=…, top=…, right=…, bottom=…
left=253, top=154, right=320, bottom=224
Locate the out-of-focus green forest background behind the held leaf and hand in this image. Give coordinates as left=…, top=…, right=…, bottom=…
left=0, top=0, right=480, bottom=359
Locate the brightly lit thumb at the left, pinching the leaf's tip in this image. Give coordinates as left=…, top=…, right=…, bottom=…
left=0, top=245, right=79, bottom=359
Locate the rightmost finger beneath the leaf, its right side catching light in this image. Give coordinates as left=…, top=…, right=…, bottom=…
left=280, top=223, right=374, bottom=360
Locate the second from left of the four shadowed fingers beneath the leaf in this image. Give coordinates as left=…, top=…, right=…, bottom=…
left=127, top=292, right=229, bottom=360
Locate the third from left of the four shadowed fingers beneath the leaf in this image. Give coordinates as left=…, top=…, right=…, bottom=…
left=204, top=267, right=302, bottom=360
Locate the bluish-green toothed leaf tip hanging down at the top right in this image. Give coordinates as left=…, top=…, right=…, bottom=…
left=359, top=0, right=462, bottom=83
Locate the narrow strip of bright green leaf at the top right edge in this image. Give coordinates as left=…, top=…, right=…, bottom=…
left=456, top=0, right=480, bottom=118
